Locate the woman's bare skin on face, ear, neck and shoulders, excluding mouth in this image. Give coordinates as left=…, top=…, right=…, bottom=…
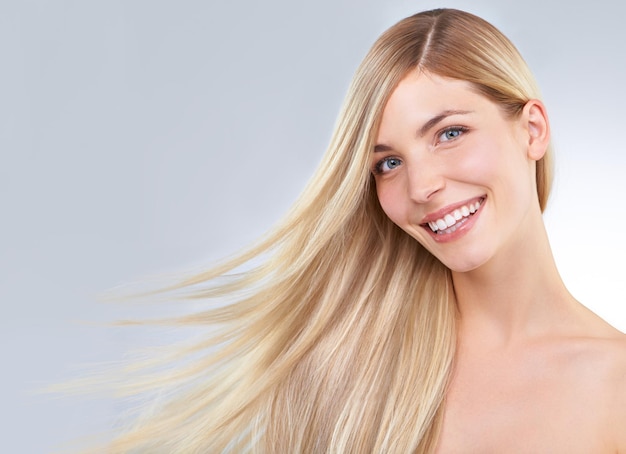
left=372, top=70, right=626, bottom=454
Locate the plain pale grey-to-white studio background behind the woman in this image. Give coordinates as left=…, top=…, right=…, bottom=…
left=0, top=0, right=626, bottom=453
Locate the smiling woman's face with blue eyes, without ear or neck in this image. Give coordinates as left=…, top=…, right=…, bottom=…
left=371, top=71, right=547, bottom=272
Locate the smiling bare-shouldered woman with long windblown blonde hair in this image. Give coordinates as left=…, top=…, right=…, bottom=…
left=111, top=9, right=626, bottom=453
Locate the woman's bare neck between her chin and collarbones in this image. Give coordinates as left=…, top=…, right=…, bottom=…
left=452, top=216, right=580, bottom=347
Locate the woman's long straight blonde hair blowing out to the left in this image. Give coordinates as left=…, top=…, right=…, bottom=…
left=108, top=9, right=551, bottom=453
